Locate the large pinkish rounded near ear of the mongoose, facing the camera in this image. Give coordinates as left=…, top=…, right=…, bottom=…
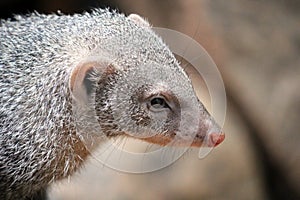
left=69, top=62, right=111, bottom=104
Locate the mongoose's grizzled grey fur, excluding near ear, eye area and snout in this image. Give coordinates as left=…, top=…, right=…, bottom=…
left=0, top=9, right=220, bottom=199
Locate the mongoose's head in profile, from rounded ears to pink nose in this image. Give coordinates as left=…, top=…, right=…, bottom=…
left=70, top=12, right=224, bottom=147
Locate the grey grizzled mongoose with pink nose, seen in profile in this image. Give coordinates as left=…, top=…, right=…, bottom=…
left=0, top=9, right=224, bottom=200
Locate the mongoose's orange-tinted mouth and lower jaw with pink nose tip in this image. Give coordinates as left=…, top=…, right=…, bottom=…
left=131, top=132, right=225, bottom=147
